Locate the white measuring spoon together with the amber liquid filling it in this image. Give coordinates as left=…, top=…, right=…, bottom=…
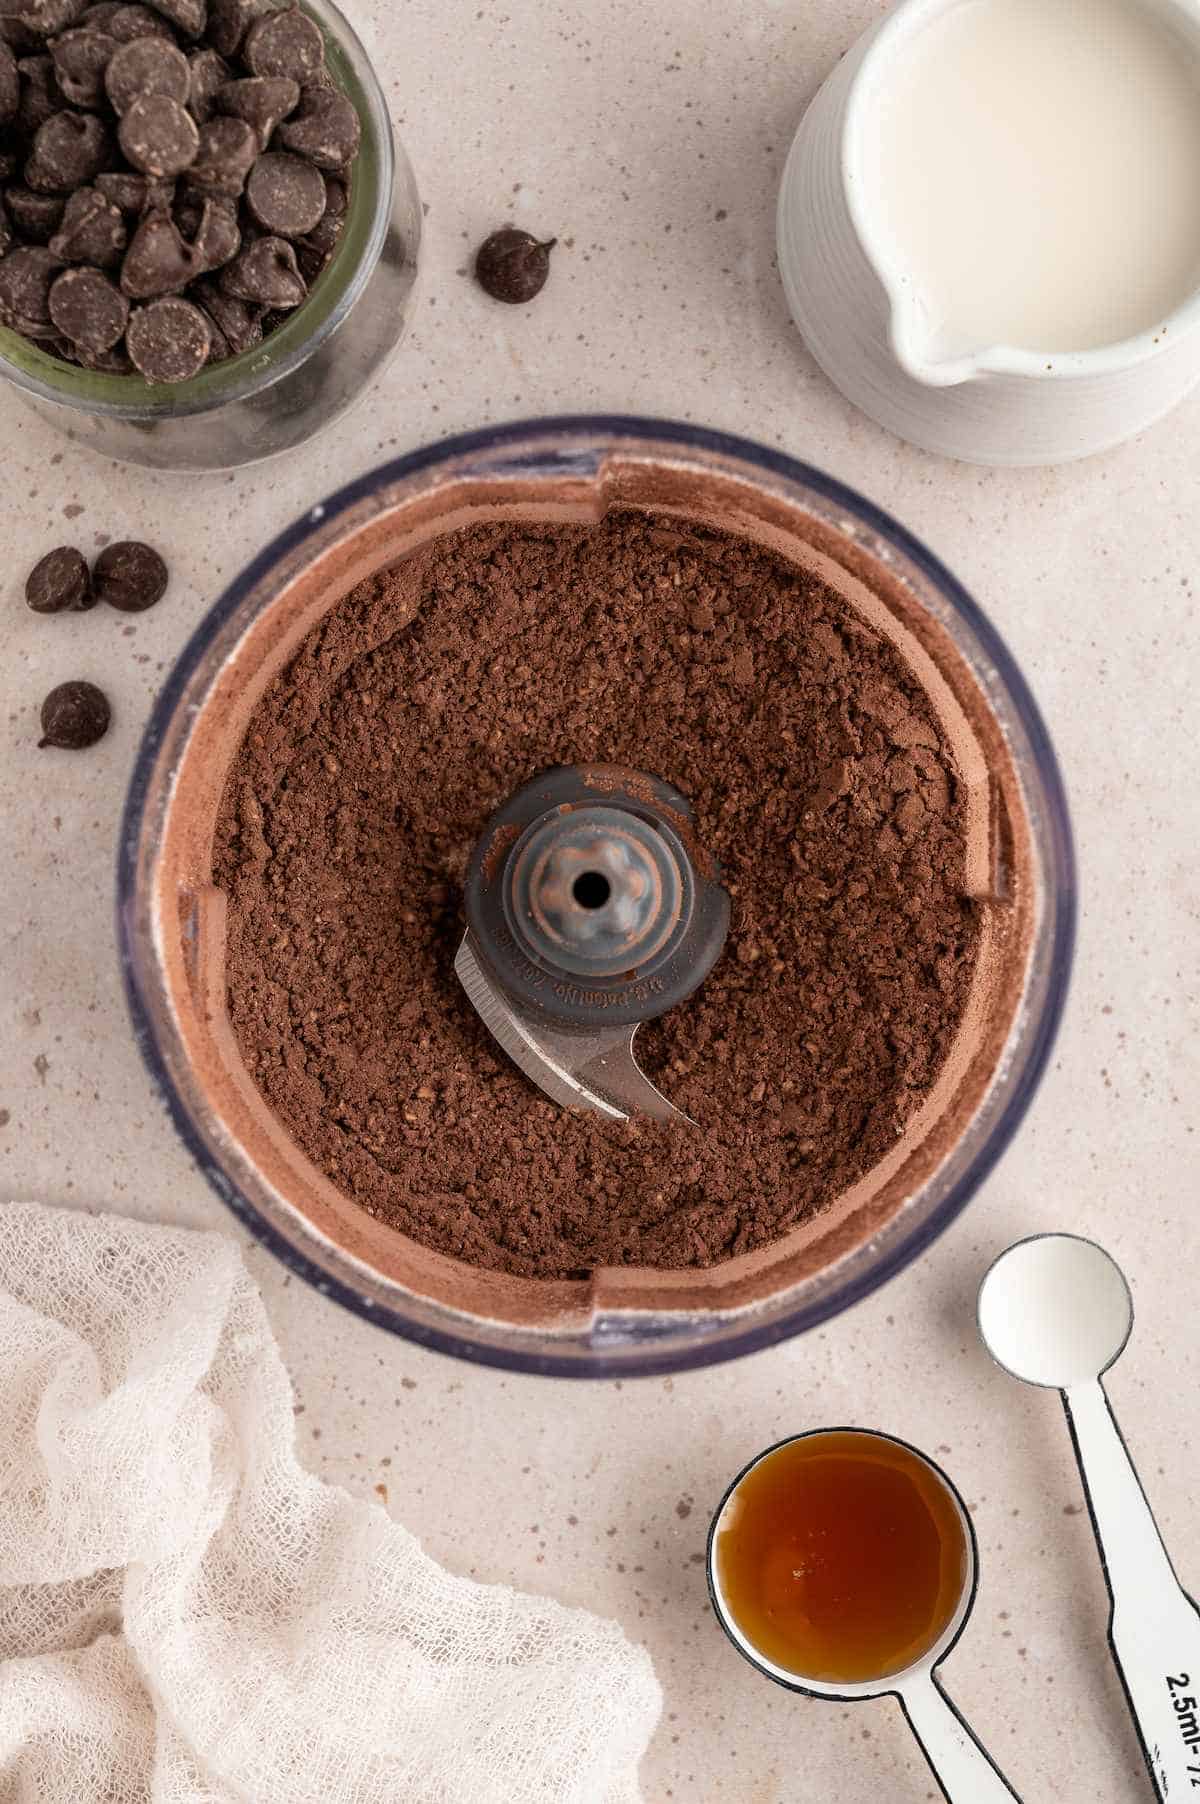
left=707, top=1429, right=1020, bottom=1804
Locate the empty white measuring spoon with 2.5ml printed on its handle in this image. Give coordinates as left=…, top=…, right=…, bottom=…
left=980, top=1234, right=1200, bottom=1804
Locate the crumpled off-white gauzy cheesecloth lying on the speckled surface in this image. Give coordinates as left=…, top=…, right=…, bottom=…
left=0, top=1203, right=660, bottom=1804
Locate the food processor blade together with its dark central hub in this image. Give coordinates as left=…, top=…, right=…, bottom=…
left=455, top=765, right=729, bottom=1122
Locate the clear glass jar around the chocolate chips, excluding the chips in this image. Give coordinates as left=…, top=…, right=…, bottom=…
left=0, top=0, right=420, bottom=471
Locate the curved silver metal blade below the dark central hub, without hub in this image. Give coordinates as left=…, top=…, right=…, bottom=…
left=455, top=933, right=695, bottom=1126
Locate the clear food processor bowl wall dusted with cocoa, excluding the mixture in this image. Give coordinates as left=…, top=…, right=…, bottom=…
left=117, top=417, right=1075, bottom=1378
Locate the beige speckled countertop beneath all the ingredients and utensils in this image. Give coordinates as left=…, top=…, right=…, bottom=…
left=0, top=0, right=1200, bottom=1804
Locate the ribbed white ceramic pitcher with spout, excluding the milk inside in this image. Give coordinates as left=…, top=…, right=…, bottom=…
left=778, top=0, right=1200, bottom=464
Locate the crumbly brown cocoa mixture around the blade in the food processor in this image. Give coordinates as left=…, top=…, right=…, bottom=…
left=217, top=512, right=978, bottom=1277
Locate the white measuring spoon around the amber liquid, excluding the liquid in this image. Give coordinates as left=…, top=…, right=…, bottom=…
left=707, top=1429, right=1020, bottom=1804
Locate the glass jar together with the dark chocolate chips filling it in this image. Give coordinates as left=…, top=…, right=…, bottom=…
left=0, top=0, right=420, bottom=469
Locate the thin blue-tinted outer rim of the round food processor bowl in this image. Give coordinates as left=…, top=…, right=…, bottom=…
left=117, top=413, right=1077, bottom=1378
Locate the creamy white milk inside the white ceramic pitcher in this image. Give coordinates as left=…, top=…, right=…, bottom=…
left=859, top=0, right=1200, bottom=364
